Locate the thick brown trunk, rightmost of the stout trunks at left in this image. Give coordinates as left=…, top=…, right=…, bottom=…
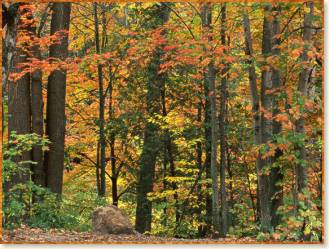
left=45, top=3, right=71, bottom=194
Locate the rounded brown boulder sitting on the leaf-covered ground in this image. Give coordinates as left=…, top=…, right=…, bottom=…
left=92, top=205, right=135, bottom=234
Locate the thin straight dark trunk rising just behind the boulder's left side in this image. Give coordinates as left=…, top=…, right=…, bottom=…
left=93, top=3, right=106, bottom=197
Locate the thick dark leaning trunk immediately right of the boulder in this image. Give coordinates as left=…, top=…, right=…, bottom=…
left=135, top=4, right=170, bottom=233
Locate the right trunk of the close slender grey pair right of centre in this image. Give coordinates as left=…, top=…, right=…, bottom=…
left=219, top=3, right=228, bottom=237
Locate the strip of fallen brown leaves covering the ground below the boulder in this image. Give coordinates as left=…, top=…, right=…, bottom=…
left=1, top=227, right=266, bottom=244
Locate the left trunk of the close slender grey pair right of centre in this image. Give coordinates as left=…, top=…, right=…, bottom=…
left=201, top=3, right=220, bottom=236
